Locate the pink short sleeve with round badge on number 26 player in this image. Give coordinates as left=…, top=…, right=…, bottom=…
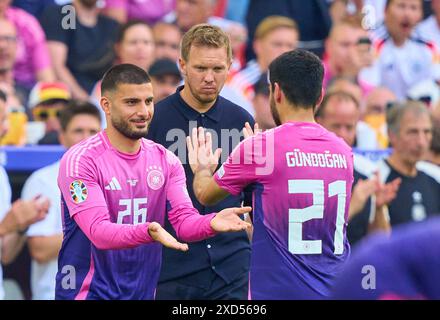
left=58, top=150, right=107, bottom=218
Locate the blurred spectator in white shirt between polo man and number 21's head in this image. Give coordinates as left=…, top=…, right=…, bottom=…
left=227, top=16, right=299, bottom=103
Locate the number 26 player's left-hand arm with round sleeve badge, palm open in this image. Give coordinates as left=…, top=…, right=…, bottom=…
left=58, top=152, right=187, bottom=250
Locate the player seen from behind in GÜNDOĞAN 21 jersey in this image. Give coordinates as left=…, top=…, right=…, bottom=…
left=187, top=50, right=353, bottom=300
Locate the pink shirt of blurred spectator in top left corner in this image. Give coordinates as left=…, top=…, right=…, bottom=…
left=0, top=0, right=55, bottom=89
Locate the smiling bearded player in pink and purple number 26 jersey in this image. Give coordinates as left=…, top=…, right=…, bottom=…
left=56, top=64, right=251, bottom=300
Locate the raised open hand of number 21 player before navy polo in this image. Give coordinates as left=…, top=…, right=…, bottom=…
left=186, top=127, right=222, bottom=174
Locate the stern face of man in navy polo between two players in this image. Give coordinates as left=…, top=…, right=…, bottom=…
left=179, top=45, right=231, bottom=107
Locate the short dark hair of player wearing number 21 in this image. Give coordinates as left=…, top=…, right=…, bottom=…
left=269, top=49, right=324, bottom=109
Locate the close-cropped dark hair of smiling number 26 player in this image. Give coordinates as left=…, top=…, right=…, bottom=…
left=101, top=63, right=151, bottom=94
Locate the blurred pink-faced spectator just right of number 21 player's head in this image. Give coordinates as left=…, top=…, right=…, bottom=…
left=323, top=16, right=374, bottom=96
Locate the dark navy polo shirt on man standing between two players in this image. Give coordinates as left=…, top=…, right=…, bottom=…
left=147, top=87, right=254, bottom=296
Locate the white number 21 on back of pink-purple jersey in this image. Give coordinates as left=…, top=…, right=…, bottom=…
left=289, top=180, right=347, bottom=254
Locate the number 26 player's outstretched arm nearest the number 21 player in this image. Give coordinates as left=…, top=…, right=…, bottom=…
left=167, top=152, right=251, bottom=242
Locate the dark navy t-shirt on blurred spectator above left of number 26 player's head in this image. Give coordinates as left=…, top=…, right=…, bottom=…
left=40, top=6, right=118, bottom=93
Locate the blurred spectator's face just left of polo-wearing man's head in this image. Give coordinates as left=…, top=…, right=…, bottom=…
left=153, top=23, right=182, bottom=61
